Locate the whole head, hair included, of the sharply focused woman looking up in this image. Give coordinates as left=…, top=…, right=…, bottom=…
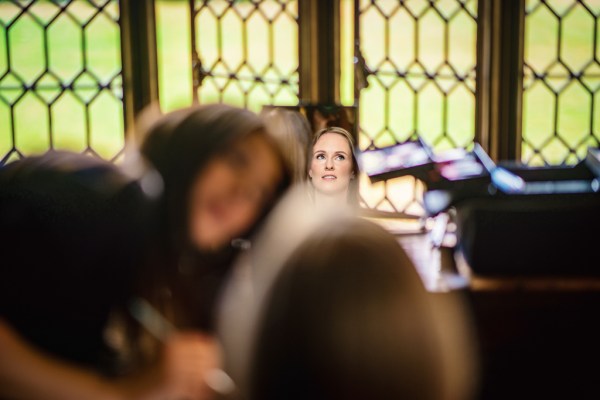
left=308, top=127, right=359, bottom=204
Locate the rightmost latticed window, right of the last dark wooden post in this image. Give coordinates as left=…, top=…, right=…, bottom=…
left=522, top=0, right=600, bottom=165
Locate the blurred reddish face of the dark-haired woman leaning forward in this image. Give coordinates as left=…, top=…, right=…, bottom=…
left=189, top=132, right=283, bottom=250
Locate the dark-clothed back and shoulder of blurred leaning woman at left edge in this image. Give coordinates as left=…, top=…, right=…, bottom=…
left=0, top=151, right=155, bottom=367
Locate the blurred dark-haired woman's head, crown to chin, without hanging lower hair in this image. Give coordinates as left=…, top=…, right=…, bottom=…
left=133, top=104, right=289, bottom=251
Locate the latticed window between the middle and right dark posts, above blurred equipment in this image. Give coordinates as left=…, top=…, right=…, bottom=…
left=358, top=0, right=477, bottom=214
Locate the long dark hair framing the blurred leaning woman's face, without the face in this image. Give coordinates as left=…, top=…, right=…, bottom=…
left=133, top=104, right=291, bottom=330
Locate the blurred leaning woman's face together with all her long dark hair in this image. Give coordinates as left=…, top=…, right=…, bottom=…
left=129, top=104, right=290, bottom=330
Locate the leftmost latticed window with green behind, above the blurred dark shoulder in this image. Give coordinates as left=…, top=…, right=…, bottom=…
left=0, top=0, right=124, bottom=163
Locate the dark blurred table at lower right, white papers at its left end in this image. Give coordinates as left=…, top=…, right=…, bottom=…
left=397, top=231, right=600, bottom=400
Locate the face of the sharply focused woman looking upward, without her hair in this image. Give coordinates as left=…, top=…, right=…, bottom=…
left=308, top=132, right=354, bottom=195
